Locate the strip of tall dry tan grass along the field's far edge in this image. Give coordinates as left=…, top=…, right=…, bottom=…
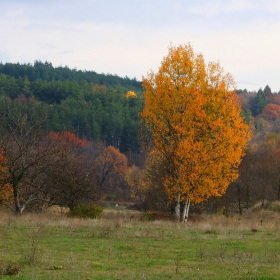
left=0, top=204, right=280, bottom=232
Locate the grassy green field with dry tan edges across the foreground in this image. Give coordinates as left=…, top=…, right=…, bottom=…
left=0, top=210, right=280, bottom=280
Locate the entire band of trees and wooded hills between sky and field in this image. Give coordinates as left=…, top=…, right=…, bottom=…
left=0, top=54, right=280, bottom=219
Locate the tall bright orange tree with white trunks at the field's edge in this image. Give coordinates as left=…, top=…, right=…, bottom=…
left=141, top=45, right=250, bottom=220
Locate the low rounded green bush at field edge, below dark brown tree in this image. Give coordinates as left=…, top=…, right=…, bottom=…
left=68, top=204, right=103, bottom=219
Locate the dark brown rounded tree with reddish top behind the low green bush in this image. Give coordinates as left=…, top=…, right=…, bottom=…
left=36, top=131, right=96, bottom=209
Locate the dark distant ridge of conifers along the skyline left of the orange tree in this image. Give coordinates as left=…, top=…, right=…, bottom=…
left=0, top=61, right=141, bottom=89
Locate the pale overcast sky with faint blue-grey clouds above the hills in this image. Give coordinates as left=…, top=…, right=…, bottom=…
left=0, top=0, right=280, bottom=92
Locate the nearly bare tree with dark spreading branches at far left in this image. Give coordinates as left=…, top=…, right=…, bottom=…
left=0, top=98, right=52, bottom=213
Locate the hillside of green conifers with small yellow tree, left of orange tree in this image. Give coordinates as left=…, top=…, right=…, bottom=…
left=0, top=61, right=143, bottom=155
